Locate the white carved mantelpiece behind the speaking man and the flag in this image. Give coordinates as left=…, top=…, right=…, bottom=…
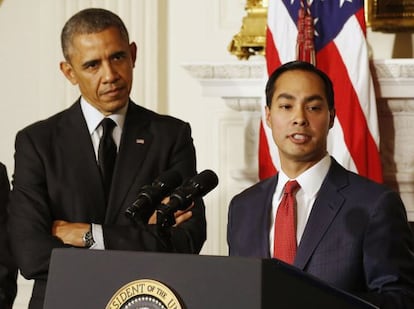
left=183, top=59, right=414, bottom=221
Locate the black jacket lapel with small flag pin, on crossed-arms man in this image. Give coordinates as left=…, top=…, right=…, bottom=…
left=105, top=102, right=153, bottom=222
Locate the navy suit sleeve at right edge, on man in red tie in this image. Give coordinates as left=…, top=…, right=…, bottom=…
left=358, top=191, right=414, bottom=308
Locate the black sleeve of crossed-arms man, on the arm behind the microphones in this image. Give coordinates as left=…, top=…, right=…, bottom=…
left=103, top=123, right=206, bottom=253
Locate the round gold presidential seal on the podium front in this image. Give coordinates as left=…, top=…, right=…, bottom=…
left=105, top=279, right=184, bottom=309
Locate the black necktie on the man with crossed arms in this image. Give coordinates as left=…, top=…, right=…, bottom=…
left=98, top=118, right=116, bottom=198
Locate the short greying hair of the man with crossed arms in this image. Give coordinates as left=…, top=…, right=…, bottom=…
left=60, top=8, right=129, bottom=61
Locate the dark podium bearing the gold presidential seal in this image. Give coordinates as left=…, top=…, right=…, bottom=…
left=44, top=249, right=376, bottom=309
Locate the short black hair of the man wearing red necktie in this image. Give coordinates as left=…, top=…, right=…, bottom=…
left=266, top=60, right=335, bottom=110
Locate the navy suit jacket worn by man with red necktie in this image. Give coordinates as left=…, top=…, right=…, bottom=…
left=227, top=160, right=414, bottom=308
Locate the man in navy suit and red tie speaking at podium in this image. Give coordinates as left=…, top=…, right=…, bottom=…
left=227, top=61, right=414, bottom=308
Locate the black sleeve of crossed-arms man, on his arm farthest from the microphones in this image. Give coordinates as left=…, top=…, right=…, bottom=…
left=8, top=131, right=65, bottom=280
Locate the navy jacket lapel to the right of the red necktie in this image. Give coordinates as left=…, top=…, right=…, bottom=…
left=294, top=159, right=348, bottom=269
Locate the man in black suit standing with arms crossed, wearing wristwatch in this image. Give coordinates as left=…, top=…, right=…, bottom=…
left=9, top=9, right=206, bottom=308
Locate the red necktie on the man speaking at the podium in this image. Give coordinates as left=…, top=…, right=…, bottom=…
left=273, top=180, right=300, bottom=264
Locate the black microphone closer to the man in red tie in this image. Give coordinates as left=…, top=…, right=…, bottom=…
left=157, top=170, right=218, bottom=227
